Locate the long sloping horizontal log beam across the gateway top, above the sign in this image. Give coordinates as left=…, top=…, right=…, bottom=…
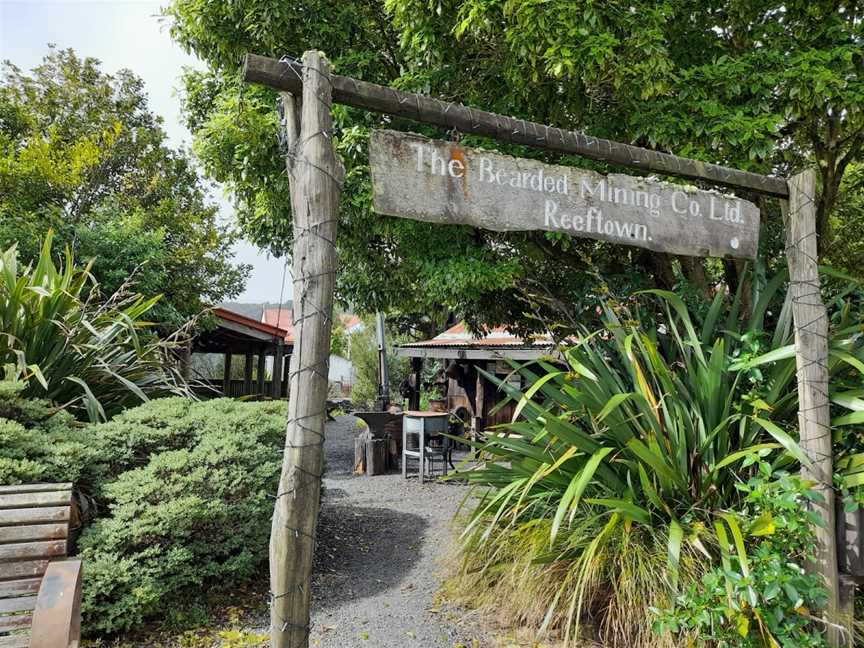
left=243, top=54, right=789, bottom=198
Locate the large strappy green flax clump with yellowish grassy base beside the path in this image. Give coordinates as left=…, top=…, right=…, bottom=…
left=454, top=275, right=864, bottom=648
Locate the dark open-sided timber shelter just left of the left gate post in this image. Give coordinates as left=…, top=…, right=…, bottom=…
left=192, top=307, right=294, bottom=398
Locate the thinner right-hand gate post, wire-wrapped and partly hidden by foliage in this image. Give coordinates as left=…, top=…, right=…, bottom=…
left=784, top=169, right=840, bottom=647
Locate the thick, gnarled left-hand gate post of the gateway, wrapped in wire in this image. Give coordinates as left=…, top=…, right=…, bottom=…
left=270, top=51, right=344, bottom=648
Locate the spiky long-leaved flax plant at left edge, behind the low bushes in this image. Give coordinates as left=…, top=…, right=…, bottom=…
left=0, top=232, right=186, bottom=420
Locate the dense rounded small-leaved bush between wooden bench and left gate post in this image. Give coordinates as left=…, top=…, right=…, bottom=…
left=72, top=398, right=285, bottom=633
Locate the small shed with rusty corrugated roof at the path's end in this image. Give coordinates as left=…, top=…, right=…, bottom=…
left=395, top=323, right=555, bottom=438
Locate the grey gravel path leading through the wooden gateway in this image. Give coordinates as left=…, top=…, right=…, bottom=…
left=298, top=416, right=486, bottom=648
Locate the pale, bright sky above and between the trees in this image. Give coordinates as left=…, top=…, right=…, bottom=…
left=0, top=0, right=291, bottom=302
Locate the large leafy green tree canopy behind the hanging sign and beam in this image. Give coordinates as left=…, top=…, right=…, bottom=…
left=167, top=0, right=864, bottom=332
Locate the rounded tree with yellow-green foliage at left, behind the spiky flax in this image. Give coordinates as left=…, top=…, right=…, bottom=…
left=0, top=49, right=248, bottom=330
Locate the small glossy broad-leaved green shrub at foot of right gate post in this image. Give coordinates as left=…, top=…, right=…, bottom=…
left=656, top=463, right=826, bottom=648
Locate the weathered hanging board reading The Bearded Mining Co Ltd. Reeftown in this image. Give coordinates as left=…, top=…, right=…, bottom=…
left=369, top=130, right=759, bottom=259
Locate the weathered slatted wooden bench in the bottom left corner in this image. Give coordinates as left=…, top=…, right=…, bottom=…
left=0, top=483, right=81, bottom=648
